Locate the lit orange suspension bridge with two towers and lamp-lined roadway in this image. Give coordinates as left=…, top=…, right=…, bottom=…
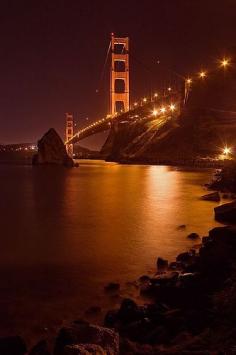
left=65, top=33, right=232, bottom=156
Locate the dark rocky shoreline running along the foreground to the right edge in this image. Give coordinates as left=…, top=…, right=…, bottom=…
left=0, top=165, right=236, bottom=355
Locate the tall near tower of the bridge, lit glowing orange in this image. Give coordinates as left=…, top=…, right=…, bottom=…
left=110, top=33, right=129, bottom=115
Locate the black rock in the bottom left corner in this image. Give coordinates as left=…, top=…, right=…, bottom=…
left=0, top=336, right=27, bottom=355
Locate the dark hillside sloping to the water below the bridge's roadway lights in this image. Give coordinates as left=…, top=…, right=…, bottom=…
left=102, top=63, right=236, bottom=164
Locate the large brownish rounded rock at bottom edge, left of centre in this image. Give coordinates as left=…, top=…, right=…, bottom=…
left=54, top=321, right=119, bottom=355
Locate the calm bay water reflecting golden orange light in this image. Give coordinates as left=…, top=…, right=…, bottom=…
left=0, top=161, right=221, bottom=340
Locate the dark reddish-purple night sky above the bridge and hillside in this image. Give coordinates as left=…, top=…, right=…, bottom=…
left=0, top=0, right=236, bottom=148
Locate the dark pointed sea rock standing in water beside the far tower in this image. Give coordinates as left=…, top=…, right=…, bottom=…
left=32, top=128, right=74, bottom=167
